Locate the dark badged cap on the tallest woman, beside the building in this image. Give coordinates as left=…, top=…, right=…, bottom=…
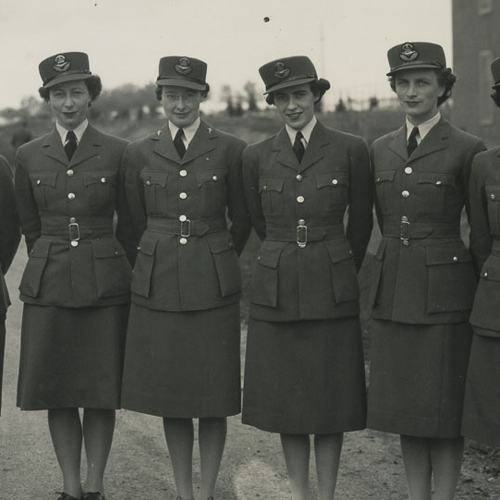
left=387, top=42, right=446, bottom=76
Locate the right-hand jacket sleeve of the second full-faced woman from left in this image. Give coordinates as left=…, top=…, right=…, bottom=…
left=228, top=141, right=252, bottom=255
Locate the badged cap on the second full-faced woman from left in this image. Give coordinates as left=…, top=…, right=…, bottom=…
left=156, top=56, right=208, bottom=90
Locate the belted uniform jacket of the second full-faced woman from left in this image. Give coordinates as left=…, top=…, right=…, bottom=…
left=123, top=121, right=251, bottom=311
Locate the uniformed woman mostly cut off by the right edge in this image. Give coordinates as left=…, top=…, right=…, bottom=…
left=462, top=58, right=500, bottom=446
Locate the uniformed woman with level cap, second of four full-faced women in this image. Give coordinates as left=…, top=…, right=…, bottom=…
left=123, top=56, right=251, bottom=500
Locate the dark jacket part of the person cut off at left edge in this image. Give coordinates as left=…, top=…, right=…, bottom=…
left=0, top=156, right=21, bottom=314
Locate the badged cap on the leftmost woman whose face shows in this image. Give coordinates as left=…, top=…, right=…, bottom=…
left=38, top=52, right=92, bottom=88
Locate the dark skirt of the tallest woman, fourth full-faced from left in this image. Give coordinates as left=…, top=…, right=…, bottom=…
left=367, top=320, right=472, bottom=438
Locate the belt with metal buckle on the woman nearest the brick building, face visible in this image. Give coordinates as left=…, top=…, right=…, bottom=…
left=382, top=217, right=460, bottom=246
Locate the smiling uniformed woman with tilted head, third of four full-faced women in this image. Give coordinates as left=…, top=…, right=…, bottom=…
left=243, top=56, right=372, bottom=500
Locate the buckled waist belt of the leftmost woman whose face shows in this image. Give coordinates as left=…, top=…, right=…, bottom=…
left=41, top=215, right=113, bottom=246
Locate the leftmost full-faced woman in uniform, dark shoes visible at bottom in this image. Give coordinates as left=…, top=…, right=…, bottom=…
left=15, top=52, right=131, bottom=500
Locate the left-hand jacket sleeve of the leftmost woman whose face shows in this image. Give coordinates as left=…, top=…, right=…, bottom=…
left=14, top=146, right=42, bottom=254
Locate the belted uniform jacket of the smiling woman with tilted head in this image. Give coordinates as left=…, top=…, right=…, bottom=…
left=243, top=122, right=373, bottom=321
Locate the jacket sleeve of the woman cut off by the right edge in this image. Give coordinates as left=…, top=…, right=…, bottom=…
left=469, top=155, right=492, bottom=274
